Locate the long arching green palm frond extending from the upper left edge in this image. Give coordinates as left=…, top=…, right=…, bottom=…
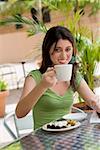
left=0, top=15, right=47, bottom=36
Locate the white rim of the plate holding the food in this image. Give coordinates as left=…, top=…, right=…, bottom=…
left=42, top=122, right=81, bottom=132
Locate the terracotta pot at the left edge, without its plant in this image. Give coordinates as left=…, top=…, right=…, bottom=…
left=0, top=91, right=9, bottom=117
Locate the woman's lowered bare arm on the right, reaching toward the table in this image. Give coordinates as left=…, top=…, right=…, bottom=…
left=77, top=79, right=100, bottom=113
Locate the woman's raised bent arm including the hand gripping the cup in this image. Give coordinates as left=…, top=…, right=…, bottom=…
left=16, top=67, right=56, bottom=118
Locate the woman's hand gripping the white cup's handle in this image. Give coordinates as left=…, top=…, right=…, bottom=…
left=41, top=67, right=57, bottom=88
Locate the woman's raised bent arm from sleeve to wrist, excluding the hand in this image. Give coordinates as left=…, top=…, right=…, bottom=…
left=16, top=76, right=46, bottom=118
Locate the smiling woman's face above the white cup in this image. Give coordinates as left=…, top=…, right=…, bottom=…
left=50, top=39, right=73, bottom=65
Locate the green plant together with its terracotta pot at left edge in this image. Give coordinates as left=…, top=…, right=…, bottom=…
left=0, top=80, right=9, bottom=117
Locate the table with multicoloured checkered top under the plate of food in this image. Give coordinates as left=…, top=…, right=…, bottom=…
left=3, top=114, right=100, bottom=150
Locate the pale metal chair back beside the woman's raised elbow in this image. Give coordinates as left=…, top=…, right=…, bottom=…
left=4, top=111, right=34, bottom=139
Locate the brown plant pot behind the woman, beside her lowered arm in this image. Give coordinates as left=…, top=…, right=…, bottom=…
left=73, top=102, right=93, bottom=112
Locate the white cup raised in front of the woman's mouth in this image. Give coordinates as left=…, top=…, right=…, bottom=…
left=54, top=64, right=72, bottom=81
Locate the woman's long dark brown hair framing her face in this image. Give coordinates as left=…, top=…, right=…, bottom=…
left=39, top=26, right=78, bottom=89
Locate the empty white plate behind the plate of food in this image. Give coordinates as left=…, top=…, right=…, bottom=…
left=62, top=113, right=87, bottom=121
